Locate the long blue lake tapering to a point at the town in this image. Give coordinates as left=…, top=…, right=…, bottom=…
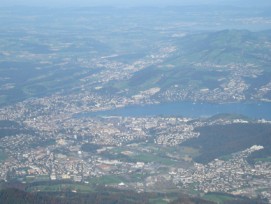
left=76, top=102, right=271, bottom=120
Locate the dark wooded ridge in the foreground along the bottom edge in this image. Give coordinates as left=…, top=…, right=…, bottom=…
left=0, top=188, right=217, bottom=204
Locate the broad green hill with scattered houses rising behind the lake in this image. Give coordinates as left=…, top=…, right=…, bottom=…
left=110, top=30, right=271, bottom=102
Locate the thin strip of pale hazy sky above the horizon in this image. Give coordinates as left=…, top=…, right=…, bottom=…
left=0, top=0, right=271, bottom=7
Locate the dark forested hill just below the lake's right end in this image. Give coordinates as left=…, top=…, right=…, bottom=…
left=182, top=123, right=271, bottom=163
